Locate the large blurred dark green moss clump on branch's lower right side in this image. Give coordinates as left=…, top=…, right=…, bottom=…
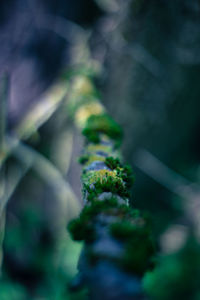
left=110, top=214, right=155, bottom=276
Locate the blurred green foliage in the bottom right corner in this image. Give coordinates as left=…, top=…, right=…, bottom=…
left=144, top=239, right=200, bottom=300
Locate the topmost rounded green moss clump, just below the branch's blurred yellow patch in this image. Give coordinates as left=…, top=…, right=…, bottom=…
left=82, top=114, right=122, bottom=146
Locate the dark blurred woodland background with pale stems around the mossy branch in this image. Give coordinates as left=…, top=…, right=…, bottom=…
left=0, top=0, right=200, bottom=300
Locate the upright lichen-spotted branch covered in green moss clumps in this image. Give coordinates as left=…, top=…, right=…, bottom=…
left=68, top=76, right=155, bottom=300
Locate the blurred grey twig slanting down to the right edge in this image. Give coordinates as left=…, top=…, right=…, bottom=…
left=133, top=149, right=200, bottom=237
